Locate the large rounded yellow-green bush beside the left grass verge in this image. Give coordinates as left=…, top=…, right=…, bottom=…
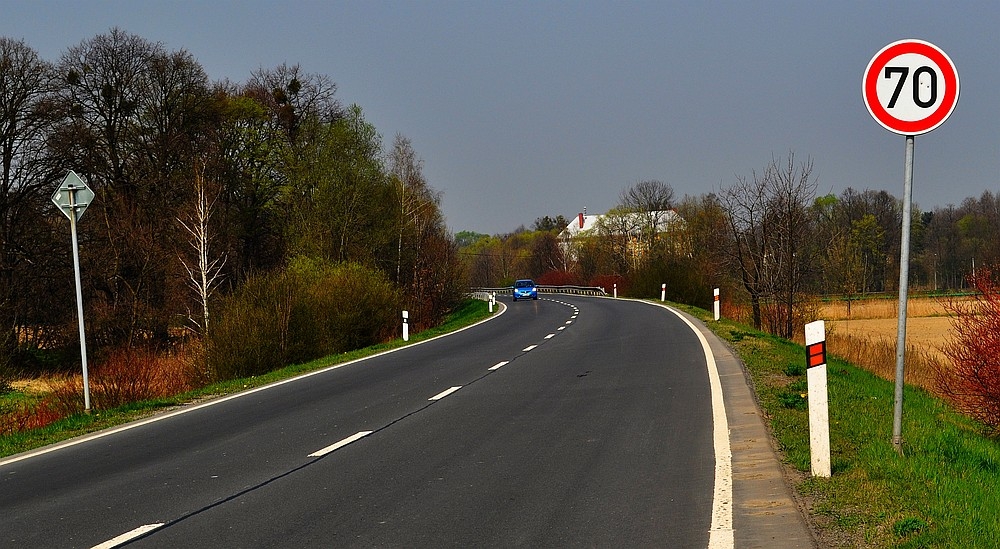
left=206, top=258, right=399, bottom=380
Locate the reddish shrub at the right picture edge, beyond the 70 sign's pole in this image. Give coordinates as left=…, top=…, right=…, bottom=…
left=937, top=269, right=1000, bottom=435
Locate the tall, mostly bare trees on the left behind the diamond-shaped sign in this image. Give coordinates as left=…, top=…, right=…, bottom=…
left=0, top=29, right=463, bottom=382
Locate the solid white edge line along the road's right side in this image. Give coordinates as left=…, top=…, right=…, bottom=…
left=654, top=303, right=736, bottom=549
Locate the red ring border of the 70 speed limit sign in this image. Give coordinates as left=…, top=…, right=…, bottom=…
left=861, top=40, right=959, bottom=135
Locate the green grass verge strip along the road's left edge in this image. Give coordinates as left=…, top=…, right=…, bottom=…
left=0, top=299, right=490, bottom=458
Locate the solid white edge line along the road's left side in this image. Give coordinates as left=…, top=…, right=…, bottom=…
left=0, top=302, right=507, bottom=467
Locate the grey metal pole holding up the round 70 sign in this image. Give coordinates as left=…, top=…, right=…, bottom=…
left=892, top=135, right=913, bottom=454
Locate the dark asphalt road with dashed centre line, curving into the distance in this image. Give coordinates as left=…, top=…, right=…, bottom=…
left=0, top=296, right=736, bottom=548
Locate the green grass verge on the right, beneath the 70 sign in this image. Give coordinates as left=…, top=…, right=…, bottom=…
left=679, top=306, right=1000, bottom=548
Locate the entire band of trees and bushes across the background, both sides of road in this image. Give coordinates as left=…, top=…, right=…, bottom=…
left=0, top=29, right=1000, bottom=406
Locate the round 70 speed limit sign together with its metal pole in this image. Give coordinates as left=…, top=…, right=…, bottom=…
left=861, top=39, right=961, bottom=454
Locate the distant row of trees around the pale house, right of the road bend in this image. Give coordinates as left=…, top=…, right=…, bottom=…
left=458, top=152, right=1000, bottom=336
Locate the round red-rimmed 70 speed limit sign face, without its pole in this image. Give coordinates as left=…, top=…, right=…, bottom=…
left=861, top=40, right=959, bottom=135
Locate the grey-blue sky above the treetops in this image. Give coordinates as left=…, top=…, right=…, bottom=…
left=0, top=0, right=1000, bottom=234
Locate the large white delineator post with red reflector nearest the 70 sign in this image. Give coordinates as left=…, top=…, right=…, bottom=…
left=806, top=320, right=830, bottom=478
